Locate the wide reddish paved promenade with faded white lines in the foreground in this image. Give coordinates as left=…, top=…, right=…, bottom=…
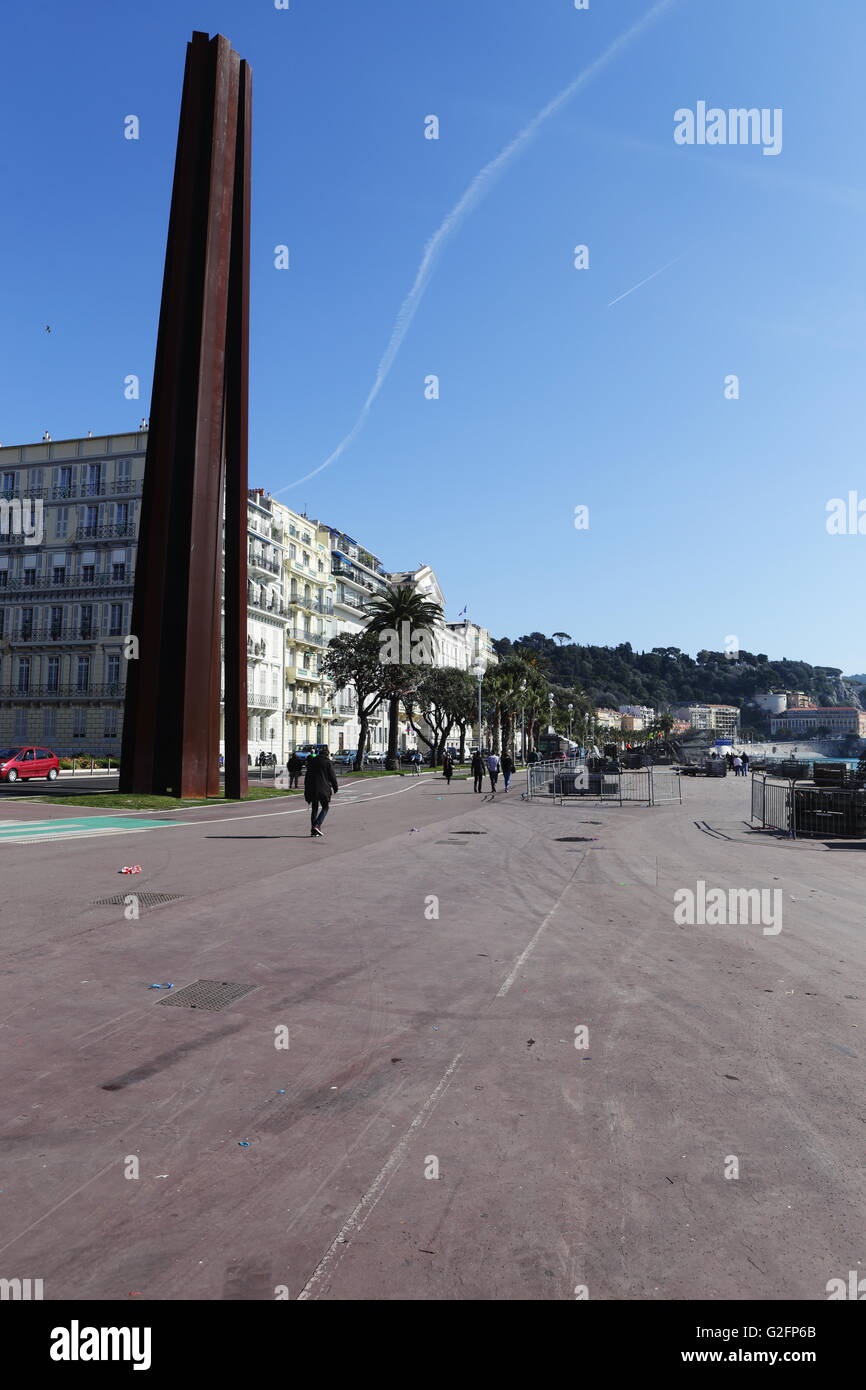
left=0, top=774, right=866, bottom=1295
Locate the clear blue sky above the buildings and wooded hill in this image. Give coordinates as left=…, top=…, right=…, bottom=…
left=0, top=0, right=866, bottom=671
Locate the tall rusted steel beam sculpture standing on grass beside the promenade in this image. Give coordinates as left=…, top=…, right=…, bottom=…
left=120, top=33, right=252, bottom=796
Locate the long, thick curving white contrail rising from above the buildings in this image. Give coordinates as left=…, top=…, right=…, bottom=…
left=274, top=0, right=677, bottom=496
